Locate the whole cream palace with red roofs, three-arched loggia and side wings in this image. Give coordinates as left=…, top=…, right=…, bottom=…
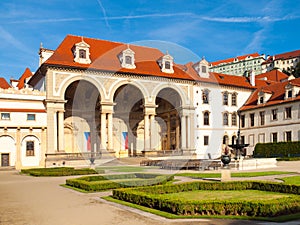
left=0, top=35, right=300, bottom=168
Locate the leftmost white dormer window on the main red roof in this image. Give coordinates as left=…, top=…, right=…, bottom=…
left=73, top=38, right=91, bottom=64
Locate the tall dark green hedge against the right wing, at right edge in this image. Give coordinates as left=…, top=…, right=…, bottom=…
left=253, top=141, right=300, bottom=158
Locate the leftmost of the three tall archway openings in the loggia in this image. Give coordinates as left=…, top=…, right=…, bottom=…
left=64, top=80, right=101, bottom=155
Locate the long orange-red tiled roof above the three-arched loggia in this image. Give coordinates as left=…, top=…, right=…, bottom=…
left=39, top=35, right=253, bottom=88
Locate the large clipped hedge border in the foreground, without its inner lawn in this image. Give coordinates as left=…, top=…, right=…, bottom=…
left=113, top=181, right=300, bottom=217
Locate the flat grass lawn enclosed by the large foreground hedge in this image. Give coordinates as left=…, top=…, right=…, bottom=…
left=164, top=190, right=291, bottom=201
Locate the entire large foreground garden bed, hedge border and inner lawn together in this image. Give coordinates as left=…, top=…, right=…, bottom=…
left=112, top=181, right=300, bottom=217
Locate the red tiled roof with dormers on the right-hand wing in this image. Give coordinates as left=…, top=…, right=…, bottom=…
left=240, top=78, right=300, bottom=110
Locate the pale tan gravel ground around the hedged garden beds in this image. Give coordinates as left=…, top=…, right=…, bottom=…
left=0, top=160, right=300, bottom=225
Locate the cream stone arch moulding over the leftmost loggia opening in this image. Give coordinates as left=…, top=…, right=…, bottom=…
left=58, top=75, right=106, bottom=99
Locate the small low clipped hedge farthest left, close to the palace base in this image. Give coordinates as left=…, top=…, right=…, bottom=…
left=21, top=167, right=97, bottom=177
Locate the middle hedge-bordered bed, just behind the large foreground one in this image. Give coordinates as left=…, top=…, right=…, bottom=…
left=66, top=173, right=174, bottom=191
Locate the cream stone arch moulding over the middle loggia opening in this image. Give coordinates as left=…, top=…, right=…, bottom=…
left=108, top=80, right=149, bottom=103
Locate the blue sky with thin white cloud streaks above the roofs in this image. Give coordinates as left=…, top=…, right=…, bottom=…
left=0, top=0, right=300, bottom=80
